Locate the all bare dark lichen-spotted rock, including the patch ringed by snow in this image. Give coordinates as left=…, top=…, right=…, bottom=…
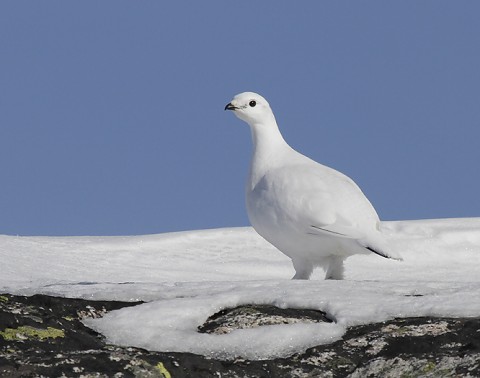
left=0, top=294, right=480, bottom=378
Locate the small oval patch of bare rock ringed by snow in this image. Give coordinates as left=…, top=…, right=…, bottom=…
left=198, top=305, right=333, bottom=335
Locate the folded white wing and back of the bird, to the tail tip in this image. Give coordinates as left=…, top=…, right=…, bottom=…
left=254, top=159, right=400, bottom=259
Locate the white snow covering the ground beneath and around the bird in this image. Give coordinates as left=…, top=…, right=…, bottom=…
left=0, top=218, right=480, bottom=359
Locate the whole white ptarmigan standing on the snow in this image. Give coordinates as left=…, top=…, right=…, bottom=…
left=225, top=92, right=398, bottom=279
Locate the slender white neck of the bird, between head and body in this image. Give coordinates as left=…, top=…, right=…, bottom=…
left=249, top=118, right=291, bottom=188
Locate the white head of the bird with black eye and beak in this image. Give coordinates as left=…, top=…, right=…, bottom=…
left=225, top=92, right=274, bottom=126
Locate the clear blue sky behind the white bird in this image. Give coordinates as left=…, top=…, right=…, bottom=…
left=0, top=0, right=480, bottom=235
